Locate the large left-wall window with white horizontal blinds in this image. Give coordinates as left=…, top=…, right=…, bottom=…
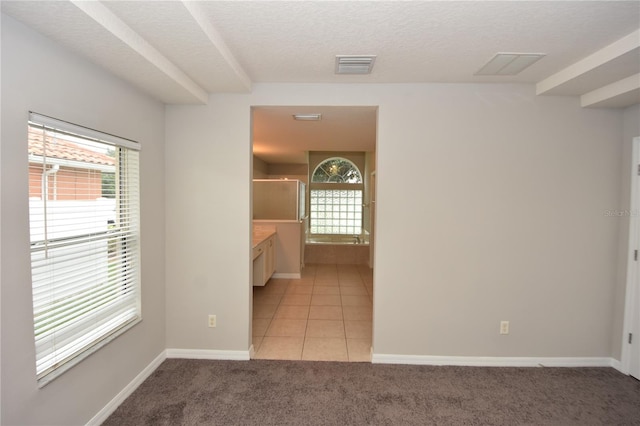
left=28, top=112, right=142, bottom=387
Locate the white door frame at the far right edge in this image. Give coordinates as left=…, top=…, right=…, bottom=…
left=620, top=137, right=640, bottom=374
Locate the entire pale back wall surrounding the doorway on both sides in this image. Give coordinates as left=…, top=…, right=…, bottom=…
left=166, top=84, right=622, bottom=357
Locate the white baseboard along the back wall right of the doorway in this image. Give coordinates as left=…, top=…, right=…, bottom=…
left=371, top=353, right=617, bottom=368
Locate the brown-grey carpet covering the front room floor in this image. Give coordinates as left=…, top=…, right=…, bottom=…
left=104, top=359, right=640, bottom=426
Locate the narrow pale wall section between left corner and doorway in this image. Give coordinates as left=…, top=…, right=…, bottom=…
left=165, top=95, right=252, bottom=355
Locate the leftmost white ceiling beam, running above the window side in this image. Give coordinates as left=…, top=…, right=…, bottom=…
left=71, top=0, right=209, bottom=104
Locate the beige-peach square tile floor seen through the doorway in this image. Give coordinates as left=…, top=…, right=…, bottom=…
left=253, top=264, right=373, bottom=362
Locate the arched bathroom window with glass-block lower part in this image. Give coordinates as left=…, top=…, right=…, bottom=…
left=309, top=157, right=364, bottom=235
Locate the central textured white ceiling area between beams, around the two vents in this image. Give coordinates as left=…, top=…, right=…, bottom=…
left=203, top=1, right=640, bottom=83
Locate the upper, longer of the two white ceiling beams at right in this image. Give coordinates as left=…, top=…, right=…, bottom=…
left=536, top=30, right=640, bottom=95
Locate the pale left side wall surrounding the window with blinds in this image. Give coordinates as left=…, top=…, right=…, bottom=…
left=1, top=15, right=165, bottom=425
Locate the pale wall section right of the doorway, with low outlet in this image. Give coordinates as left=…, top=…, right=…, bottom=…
left=374, top=85, right=622, bottom=357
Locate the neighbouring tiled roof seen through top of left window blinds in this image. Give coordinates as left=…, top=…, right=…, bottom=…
left=29, top=127, right=115, bottom=166
